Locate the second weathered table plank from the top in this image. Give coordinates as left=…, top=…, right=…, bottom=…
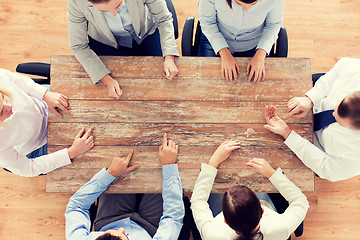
left=51, top=75, right=312, bottom=102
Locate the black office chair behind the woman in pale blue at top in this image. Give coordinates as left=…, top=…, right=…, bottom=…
left=181, top=17, right=288, bottom=57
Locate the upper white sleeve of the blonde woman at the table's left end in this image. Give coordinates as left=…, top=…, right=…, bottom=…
left=0, top=69, right=47, bottom=100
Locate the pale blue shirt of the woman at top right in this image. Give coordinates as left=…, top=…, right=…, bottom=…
left=199, top=0, right=285, bottom=54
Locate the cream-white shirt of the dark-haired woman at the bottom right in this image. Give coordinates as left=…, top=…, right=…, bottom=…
left=191, top=163, right=309, bottom=240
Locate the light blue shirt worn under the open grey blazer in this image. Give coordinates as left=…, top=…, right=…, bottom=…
left=103, top=1, right=146, bottom=48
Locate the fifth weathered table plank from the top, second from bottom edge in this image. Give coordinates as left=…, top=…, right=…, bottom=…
left=48, top=146, right=311, bottom=169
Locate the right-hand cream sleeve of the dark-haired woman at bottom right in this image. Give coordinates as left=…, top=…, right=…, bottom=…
left=269, top=168, right=309, bottom=236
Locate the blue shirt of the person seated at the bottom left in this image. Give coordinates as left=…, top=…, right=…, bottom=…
left=65, top=164, right=185, bottom=240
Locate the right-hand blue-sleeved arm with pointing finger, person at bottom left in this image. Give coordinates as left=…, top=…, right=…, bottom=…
left=153, top=134, right=185, bottom=240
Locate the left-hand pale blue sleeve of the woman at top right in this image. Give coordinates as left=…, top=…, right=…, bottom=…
left=199, top=0, right=229, bottom=54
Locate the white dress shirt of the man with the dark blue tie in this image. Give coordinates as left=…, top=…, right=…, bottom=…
left=285, top=58, right=360, bottom=182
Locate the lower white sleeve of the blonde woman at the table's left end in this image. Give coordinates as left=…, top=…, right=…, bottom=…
left=0, top=148, right=71, bottom=177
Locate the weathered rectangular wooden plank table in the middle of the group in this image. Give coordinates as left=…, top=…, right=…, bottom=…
left=46, top=56, right=314, bottom=193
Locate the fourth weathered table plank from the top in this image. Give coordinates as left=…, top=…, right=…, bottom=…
left=48, top=122, right=312, bottom=147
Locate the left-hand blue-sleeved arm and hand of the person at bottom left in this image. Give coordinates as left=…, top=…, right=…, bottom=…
left=65, top=150, right=138, bottom=240
